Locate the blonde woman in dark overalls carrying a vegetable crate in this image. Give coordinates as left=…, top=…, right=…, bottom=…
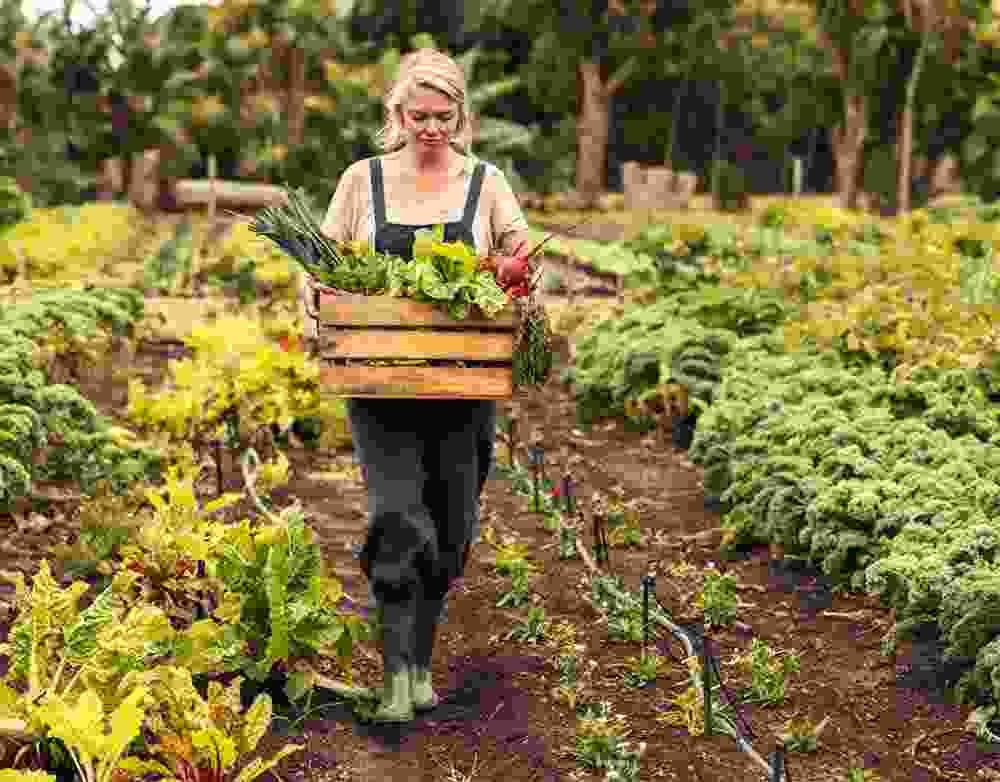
left=322, top=49, right=533, bottom=722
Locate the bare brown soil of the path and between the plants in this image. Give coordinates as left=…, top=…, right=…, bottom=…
left=0, top=222, right=1000, bottom=782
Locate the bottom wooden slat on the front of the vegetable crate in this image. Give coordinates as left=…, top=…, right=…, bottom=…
left=320, top=366, right=514, bottom=399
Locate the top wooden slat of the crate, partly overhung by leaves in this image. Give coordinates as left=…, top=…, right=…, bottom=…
left=319, top=292, right=517, bottom=331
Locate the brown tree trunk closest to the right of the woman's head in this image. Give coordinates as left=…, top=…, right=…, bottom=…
left=576, top=62, right=611, bottom=205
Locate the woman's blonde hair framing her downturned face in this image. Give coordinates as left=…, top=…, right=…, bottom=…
left=375, top=47, right=469, bottom=155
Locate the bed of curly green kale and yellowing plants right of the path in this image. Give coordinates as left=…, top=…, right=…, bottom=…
left=564, top=194, right=1000, bottom=728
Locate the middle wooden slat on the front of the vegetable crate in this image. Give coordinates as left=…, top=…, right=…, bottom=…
left=318, top=328, right=514, bottom=361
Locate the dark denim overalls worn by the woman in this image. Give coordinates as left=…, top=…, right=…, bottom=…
left=347, top=158, right=496, bottom=670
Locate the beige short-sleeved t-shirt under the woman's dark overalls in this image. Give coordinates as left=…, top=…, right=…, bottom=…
left=321, top=154, right=528, bottom=255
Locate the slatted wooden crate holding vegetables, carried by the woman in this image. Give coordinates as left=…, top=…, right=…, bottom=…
left=308, top=285, right=518, bottom=399
